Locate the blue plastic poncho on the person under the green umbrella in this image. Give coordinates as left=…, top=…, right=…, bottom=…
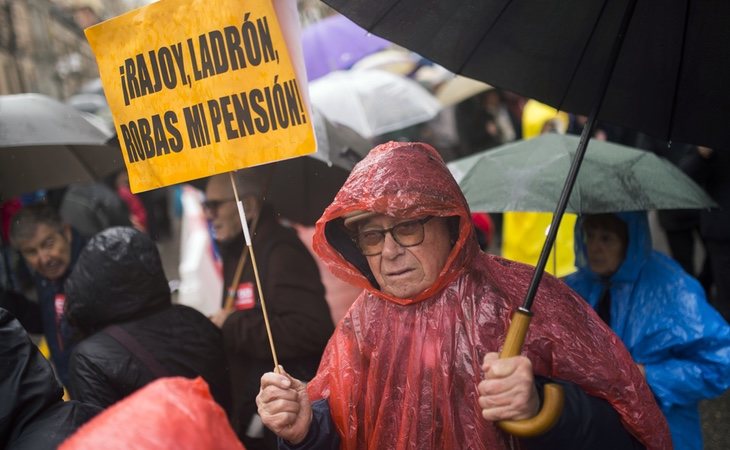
left=566, top=212, right=730, bottom=449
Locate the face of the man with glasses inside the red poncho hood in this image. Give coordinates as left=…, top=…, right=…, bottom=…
left=358, top=215, right=452, bottom=298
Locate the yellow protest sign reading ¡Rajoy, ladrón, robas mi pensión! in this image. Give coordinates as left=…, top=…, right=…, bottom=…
left=86, top=0, right=316, bottom=192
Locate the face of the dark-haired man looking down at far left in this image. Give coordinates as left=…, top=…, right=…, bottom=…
left=18, top=223, right=71, bottom=281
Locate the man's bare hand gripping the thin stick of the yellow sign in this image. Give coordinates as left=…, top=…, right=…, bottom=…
left=256, top=366, right=312, bottom=445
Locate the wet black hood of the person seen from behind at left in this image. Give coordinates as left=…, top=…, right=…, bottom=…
left=65, top=227, right=172, bottom=334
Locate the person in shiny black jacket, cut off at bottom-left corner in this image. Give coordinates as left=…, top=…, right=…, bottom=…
left=0, top=308, right=99, bottom=450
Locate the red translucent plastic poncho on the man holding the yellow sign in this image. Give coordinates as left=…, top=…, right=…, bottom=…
left=308, top=142, right=670, bottom=450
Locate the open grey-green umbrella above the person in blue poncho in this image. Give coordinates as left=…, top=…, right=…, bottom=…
left=448, top=133, right=717, bottom=214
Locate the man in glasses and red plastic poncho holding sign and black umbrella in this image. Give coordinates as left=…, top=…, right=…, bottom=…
left=257, top=142, right=671, bottom=450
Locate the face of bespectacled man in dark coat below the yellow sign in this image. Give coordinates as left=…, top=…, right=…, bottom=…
left=203, top=176, right=243, bottom=242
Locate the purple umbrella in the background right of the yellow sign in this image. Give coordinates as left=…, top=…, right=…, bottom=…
left=302, top=14, right=391, bottom=81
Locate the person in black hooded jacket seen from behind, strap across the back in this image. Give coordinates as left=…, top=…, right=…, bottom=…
left=65, top=227, right=230, bottom=418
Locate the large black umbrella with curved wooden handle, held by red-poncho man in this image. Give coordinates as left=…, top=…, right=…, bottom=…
left=324, top=0, right=730, bottom=436
